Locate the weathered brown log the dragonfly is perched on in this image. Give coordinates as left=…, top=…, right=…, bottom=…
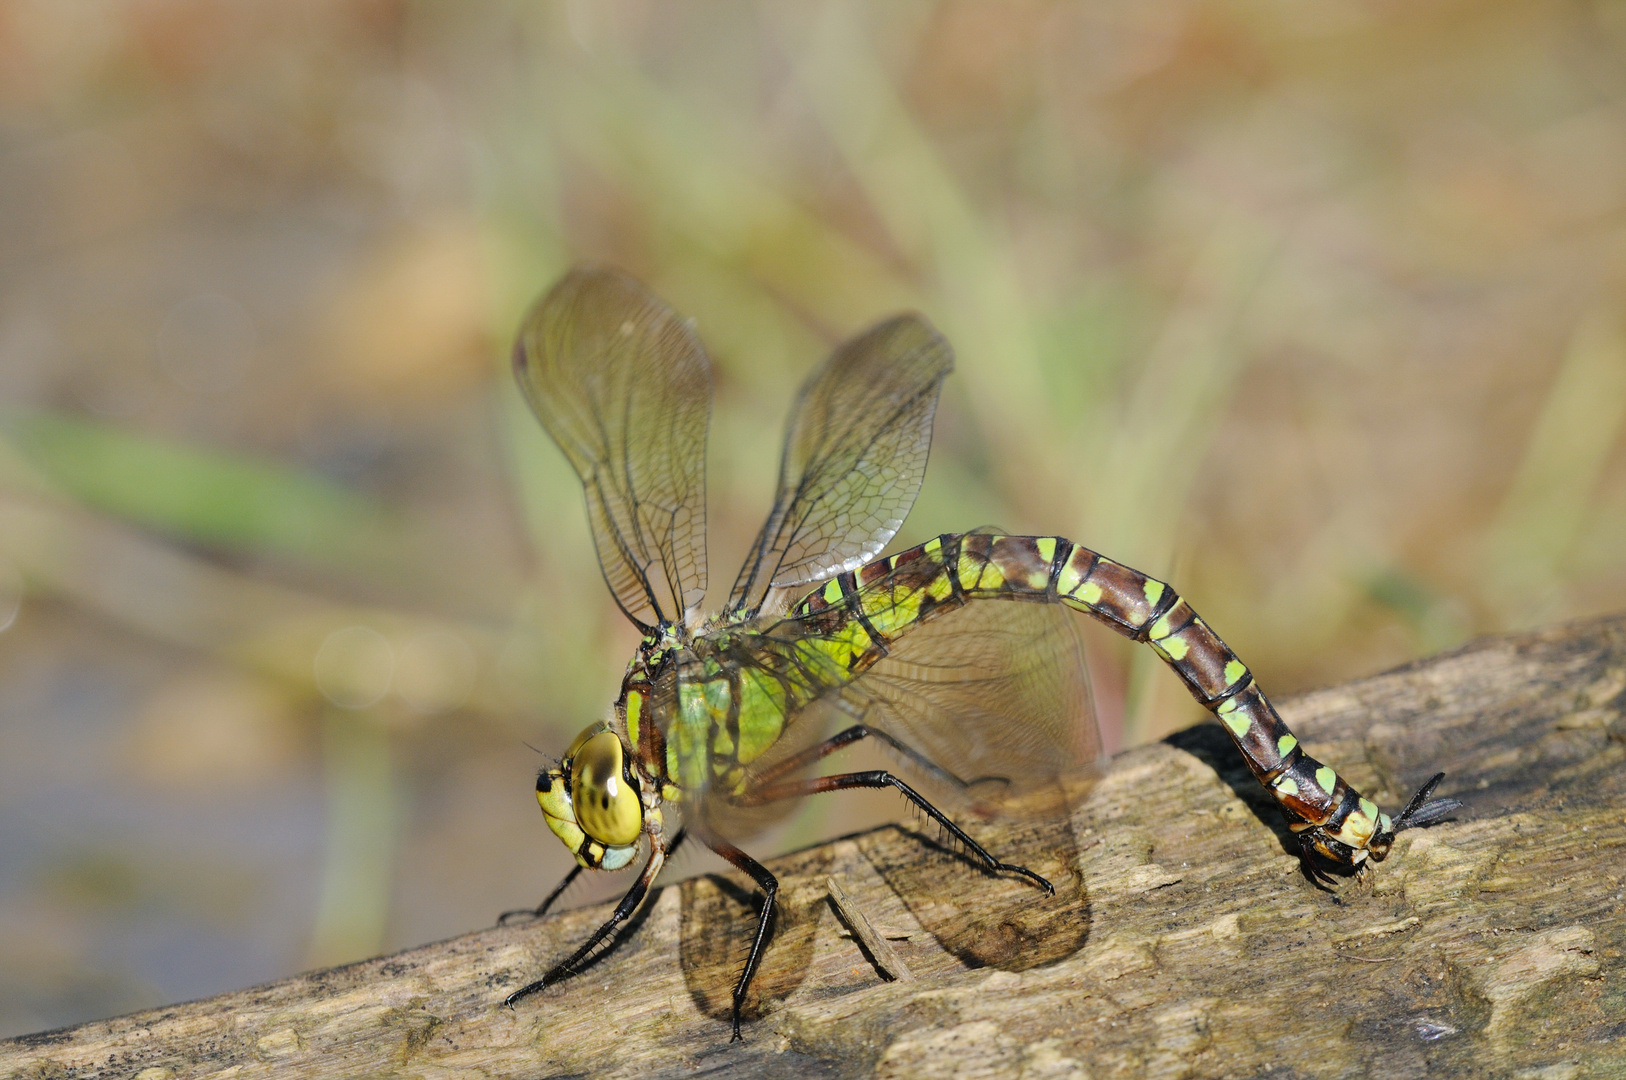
left=0, top=616, right=1626, bottom=1080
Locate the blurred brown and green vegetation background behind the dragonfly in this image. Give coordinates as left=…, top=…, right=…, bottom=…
left=0, top=0, right=1626, bottom=1034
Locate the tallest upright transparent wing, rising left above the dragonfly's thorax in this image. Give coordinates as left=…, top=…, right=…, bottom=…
left=514, top=267, right=712, bottom=629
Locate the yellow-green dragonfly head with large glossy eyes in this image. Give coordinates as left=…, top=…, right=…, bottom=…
left=537, top=721, right=644, bottom=870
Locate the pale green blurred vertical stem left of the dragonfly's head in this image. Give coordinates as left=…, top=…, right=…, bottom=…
left=306, top=709, right=400, bottom=968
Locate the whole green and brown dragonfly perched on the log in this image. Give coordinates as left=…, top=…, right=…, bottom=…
left=506, top=265, right=1460, bottom=1039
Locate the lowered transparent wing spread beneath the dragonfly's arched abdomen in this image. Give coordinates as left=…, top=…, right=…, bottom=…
left=706, top=600, right=1101, bottom=836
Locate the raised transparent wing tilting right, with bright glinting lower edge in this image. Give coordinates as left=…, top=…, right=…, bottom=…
left=728, top=316, right=954, bottom=612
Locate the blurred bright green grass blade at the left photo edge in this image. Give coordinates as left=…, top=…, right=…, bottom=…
left=0, top=413, right=400, bottom=564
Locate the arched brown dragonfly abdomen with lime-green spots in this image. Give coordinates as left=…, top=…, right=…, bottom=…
left=792, top=533, right=1390, bottom=860
